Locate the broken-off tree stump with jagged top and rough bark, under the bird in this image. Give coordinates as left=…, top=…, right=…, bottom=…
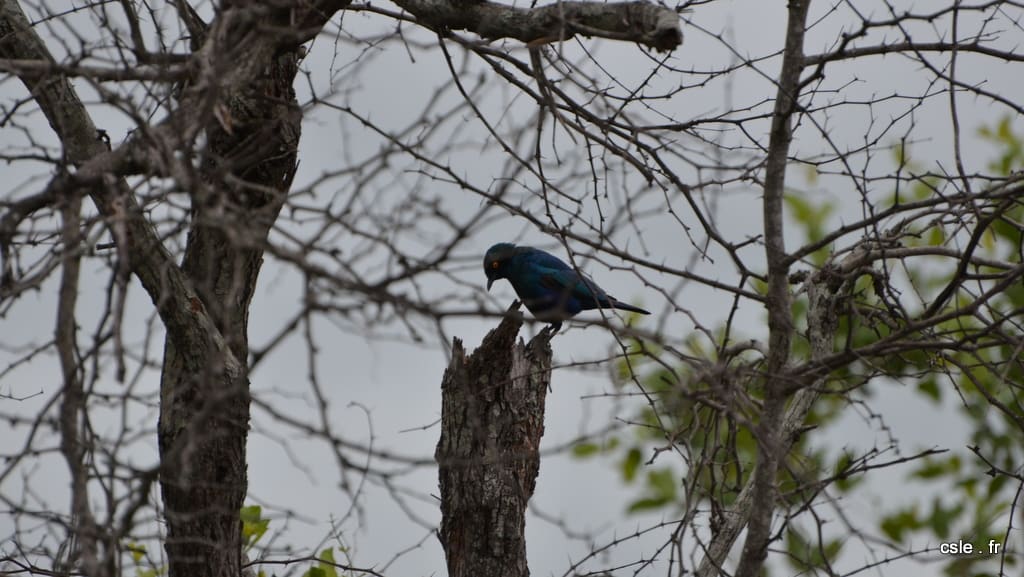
left=434, top=315, right=551, bottom=577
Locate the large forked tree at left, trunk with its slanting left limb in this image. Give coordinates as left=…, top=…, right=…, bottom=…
left=0, top=0, right=319, bottom=577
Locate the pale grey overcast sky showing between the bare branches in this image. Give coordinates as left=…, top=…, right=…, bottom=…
left=0, top=0, right=1024, bottom=576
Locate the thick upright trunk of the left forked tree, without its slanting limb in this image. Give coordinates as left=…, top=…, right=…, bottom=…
left=159, top=42, right=301, bottom=577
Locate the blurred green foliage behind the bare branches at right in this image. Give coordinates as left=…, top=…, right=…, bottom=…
left=574, top=117, right=1024, bottom=576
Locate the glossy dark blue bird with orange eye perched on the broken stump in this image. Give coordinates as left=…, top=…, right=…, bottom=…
left=483, top=243, right=650, bottom=332
